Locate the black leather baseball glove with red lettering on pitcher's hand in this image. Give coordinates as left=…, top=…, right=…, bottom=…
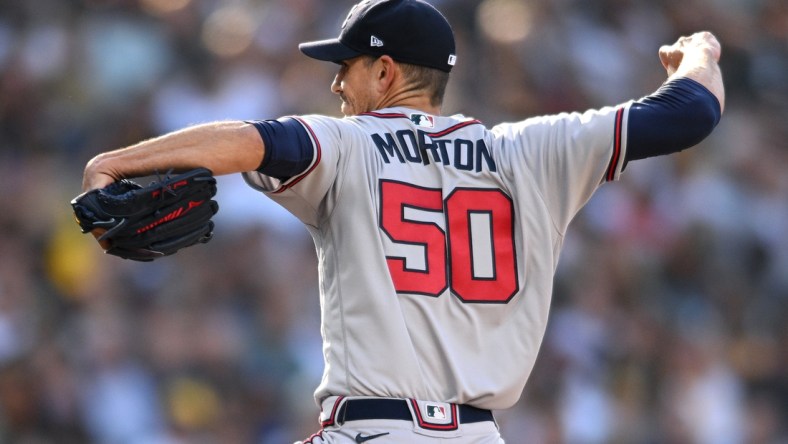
left=71, top=168, right=219, bottom=262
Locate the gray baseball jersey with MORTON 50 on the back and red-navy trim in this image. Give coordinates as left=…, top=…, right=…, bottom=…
left=245, top=104, right=629, bottom=409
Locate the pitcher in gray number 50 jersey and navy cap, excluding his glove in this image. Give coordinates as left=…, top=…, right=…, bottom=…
left=77, top=0, right=724, bottom=444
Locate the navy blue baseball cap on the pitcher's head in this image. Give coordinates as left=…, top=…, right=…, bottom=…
left=298, top=0, right=457, bottom=72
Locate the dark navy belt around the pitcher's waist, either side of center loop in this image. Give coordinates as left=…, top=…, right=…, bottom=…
left=337, top=398, right=494, bottom=424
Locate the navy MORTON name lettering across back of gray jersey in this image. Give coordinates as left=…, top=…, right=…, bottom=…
left=372, top=129, right=498, bottom=173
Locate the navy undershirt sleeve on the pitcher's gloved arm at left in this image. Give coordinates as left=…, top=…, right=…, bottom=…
left=248, top=117, right=315, bottom=181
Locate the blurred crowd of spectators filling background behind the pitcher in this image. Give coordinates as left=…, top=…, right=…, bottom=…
left=0, top=0, right=788, bottom=444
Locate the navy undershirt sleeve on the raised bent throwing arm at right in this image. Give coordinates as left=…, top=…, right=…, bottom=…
left=625, top=78, right=722, bottom=162
